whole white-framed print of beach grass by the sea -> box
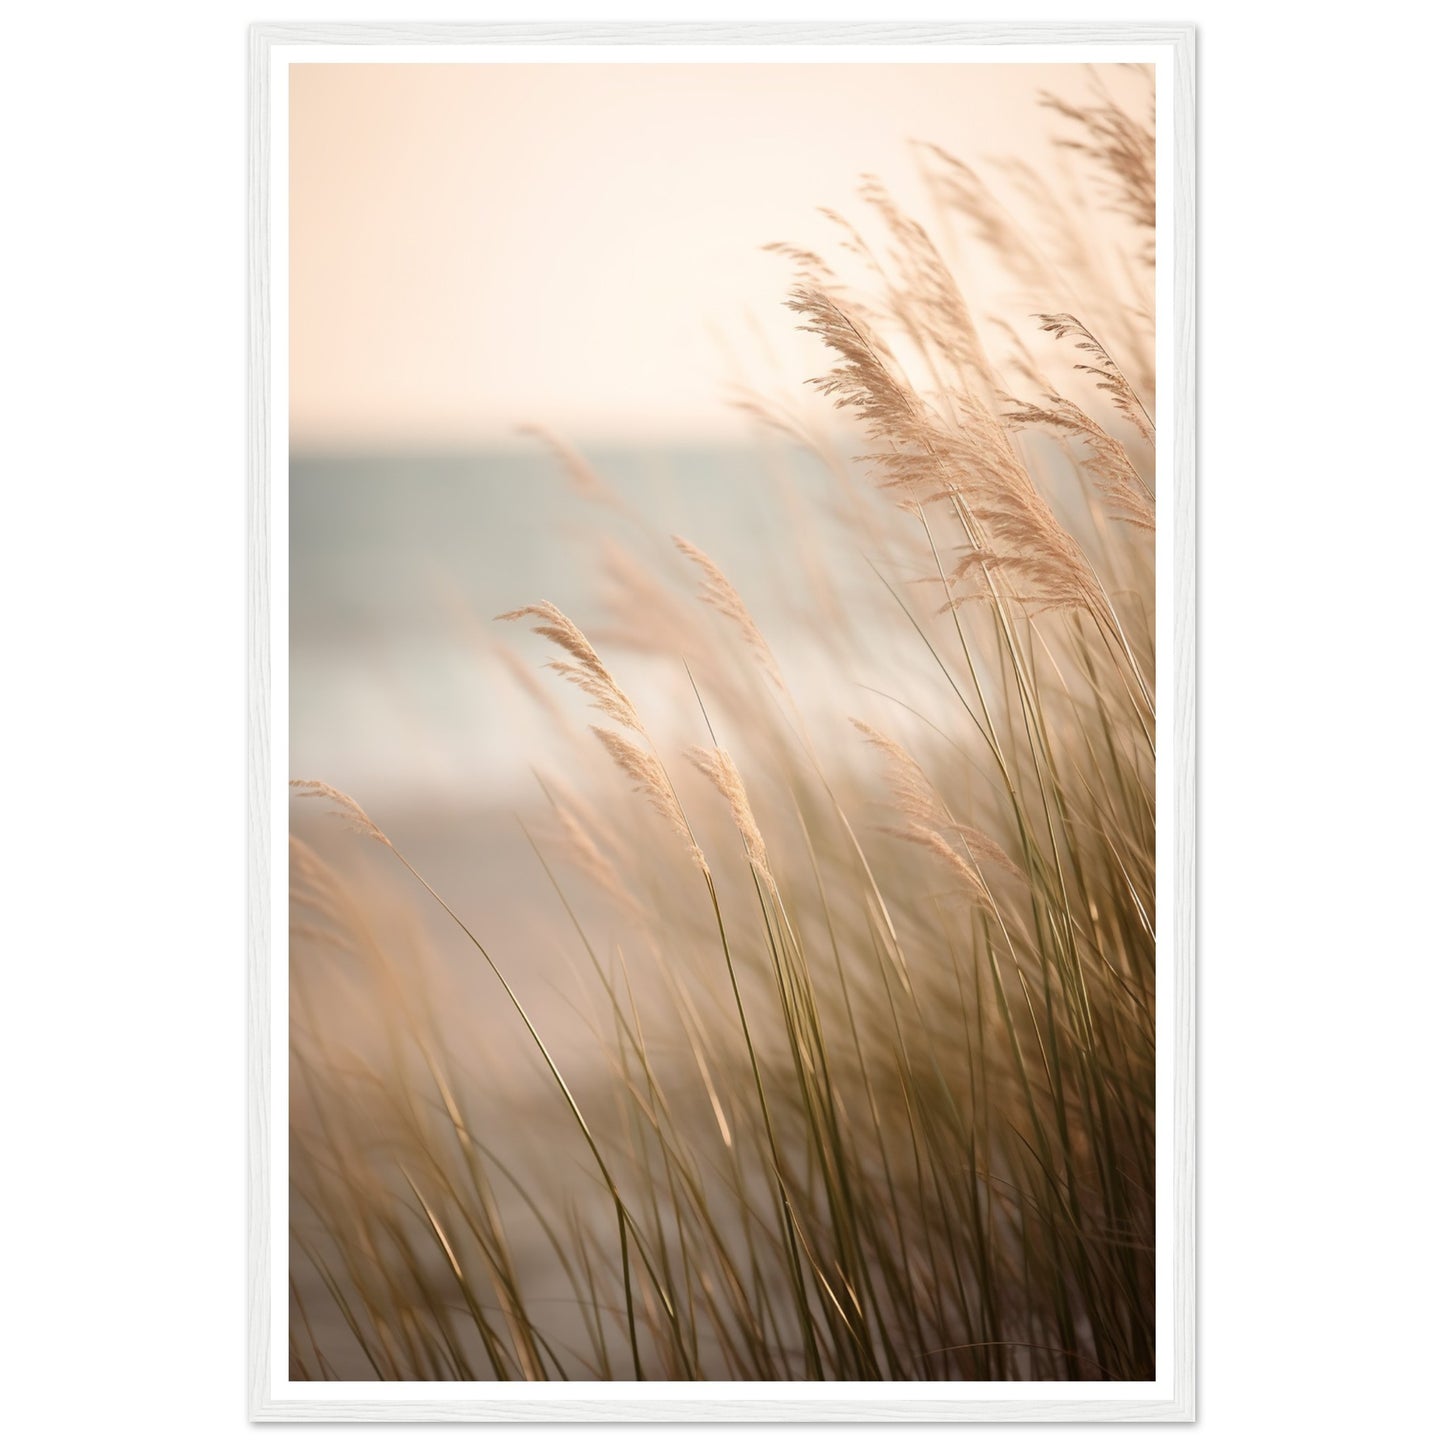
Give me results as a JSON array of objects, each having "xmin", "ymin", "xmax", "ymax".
[{"xmin": 250, "ymin": 25, "xmax": 1195, "ymax": 1422}]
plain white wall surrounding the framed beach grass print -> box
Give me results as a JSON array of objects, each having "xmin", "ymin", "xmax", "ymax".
[{"xmin": 0, "ymin": 0, "xmax": 1442, "ymax": 1442}]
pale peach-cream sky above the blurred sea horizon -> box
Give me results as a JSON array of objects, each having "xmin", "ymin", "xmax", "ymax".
[{"xmin": 290, "ymin": 64, "xmax": 1138, "ymax": 449}]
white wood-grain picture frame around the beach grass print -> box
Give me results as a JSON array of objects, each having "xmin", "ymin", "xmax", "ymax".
[{"xmin": 247, "ymin": 22, "xmax": 1195, "ymax": 1423}]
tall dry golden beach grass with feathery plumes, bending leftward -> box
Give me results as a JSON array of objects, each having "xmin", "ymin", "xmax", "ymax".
[{"xmin": 292, "ymin": 82, "xmax": 1155, "ymax": 1380}]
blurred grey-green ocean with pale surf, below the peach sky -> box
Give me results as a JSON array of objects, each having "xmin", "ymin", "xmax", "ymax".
[{"xmin": 289, "ymin": 445, "xmax": 857, "ymax": 808}]
